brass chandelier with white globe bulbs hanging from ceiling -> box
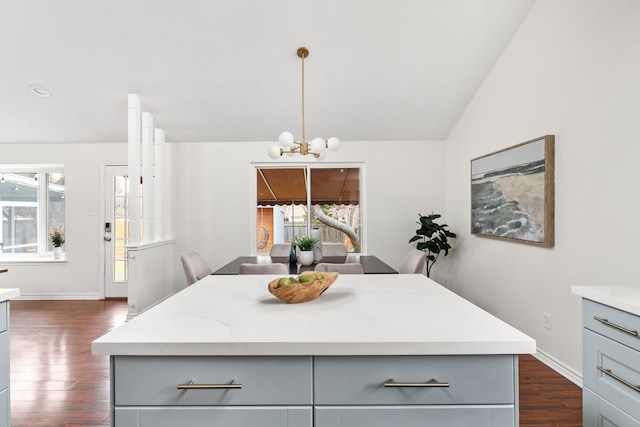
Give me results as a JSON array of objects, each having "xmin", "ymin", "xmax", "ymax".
[{"xmin": 269, "ymin": 47, "xmax": 340, "ymax": 160}]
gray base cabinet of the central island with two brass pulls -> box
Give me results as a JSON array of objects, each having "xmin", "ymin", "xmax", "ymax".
[{"xmin": 111, "ymin": 355, "xmax": 518, "ymax": 427}]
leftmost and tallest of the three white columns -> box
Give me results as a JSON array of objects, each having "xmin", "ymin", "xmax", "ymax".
[{"xmin": 127, "ymin": 94, "xmax": 141, "ymax": 246}]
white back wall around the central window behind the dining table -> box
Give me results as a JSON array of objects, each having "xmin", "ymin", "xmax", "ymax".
[{"xmin": 173, "ymin": 141, "xmax": 445, "ymax": 286}]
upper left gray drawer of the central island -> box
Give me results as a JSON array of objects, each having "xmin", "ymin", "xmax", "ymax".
[{"xmin": 117, "ymin": 356, "xmax": 313, "ymax": 406}]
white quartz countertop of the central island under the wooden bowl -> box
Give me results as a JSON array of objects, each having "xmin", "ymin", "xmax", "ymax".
[{"xmin": 92, "ymin": 274, "xmax": 536, "ymax": 356}]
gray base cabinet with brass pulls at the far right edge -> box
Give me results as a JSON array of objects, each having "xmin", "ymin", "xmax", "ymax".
[{"xmin": 583, "ymin": 299, "xmax": 640, "ymax": 427}]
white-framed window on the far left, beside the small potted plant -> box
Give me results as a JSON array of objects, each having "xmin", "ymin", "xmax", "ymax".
[{"xmin": 0, "ymin": 165, "xmax": 65, "ymax": 260}]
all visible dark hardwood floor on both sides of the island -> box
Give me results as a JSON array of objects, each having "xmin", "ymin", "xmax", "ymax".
[{"xmin": 11, "ymin": 300, "xmax": 582, "ymax": 427}]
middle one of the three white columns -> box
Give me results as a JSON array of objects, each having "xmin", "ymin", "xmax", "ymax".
[{"xmin": 142, "ymin": 113, "xmax": 156, "ymax": 243}]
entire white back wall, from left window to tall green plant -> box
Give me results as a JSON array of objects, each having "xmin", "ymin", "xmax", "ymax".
[{"xmin": 0, "ymin": 141, "xmax": 445, "ymax": 299}]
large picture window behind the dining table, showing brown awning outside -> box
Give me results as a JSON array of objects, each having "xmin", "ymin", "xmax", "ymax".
[{"xmin": 256, "ymin": 166, "xmax": 362, "ymax": 254}]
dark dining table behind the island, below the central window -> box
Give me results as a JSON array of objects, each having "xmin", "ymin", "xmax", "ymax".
[{"xmin": 211, "ymin": 254, "xmax": 398, "ymax": 275}]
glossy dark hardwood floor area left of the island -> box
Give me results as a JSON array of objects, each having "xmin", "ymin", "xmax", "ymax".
[{"xmin": 10, "ymin": 300, "xmax": 127, "ymax": 427}]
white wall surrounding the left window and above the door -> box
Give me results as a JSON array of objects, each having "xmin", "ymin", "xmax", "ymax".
[{"xmin": 0, "ymin": 143, "xmax": 127, "ymax": 299}]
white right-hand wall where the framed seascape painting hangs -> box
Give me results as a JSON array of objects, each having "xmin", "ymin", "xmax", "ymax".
[{"xmin": 446, "ymin": 0, "xmax": 640, "ymax": 380}]
